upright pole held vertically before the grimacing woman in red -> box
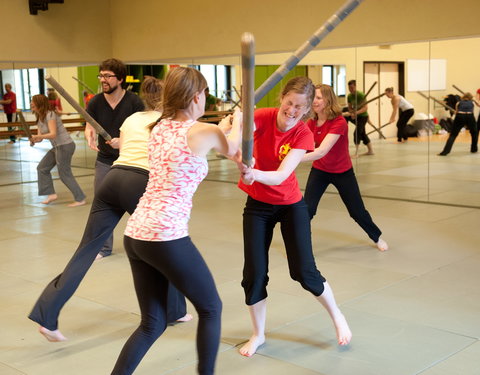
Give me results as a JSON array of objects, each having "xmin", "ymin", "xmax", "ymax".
[{"xmin": 241, "ymin": 33, "xmax": 255, "ymax": 167}]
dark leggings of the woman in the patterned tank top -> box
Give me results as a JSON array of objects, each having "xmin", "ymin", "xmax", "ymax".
[{"xmin": 112, "ymin": 236, "xmax": 222, "ymax": 375}]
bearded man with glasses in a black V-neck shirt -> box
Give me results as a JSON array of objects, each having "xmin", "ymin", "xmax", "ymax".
[{"xmin": 85, "ymin": 59, "xmax": 144, "ymax": 259}]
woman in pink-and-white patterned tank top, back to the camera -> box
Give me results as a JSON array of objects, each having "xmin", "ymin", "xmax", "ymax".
[{"xmin": 112, "ymin": 67, "xmax": 241, "ymax": 374}]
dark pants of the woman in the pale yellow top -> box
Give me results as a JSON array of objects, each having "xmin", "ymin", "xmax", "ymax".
[{"xmin": 28, "ymin": 167, "xmax": 186, "ymax": 331}]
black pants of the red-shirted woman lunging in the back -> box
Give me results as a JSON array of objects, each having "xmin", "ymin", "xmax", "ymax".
[{"xmin": 305, "ymin": 168, "xmax": 382, "ymax": 243}]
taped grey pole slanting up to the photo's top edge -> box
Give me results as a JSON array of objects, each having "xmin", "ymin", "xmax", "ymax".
[{"xmin": 255, "ymin": 0, "xmax": 363, "ymax": 104}]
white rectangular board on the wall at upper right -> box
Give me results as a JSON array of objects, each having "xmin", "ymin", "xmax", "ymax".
[{"xmin": 407, "ymin": 59, "xmax": 447, "ymax": 91}]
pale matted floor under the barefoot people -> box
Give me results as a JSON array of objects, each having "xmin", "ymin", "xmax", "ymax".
[{"xmin": 0, "ymin": 137, "xmax": 480, "ymax": 375}]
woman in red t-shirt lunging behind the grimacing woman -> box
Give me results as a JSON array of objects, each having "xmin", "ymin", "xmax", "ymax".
[{"xmin": 302, "ymin": 85, "xmax": 388, "ymax": 251}]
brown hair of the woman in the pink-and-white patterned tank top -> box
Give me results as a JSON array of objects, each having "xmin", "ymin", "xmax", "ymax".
[{"xmin": 149, "ymin": 66, "xmax": 207, "ymax": 130}]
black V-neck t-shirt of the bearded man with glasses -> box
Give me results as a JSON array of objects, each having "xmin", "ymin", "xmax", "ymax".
[{"xmin": 87, "ymin": 91, "xmax": 144, "ymax": 165}]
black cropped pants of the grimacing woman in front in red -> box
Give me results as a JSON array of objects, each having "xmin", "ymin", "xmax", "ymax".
[{"xmin": 242, "ymin": 197, "xmax": 325, "ymax": 305}]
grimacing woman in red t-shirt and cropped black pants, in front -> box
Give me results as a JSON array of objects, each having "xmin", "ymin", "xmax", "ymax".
[{"xmin": 239, "ymin": 77, "xmax": 352, "ymax": 357}]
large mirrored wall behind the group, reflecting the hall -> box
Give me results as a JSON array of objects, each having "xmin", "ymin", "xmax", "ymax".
[{"xmin": 0, "ymin": 38, "xmax": 480, "ymax": 207}]
